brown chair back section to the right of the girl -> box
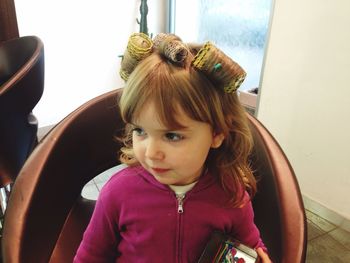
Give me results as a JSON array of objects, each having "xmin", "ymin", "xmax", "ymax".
[{"xmin": 248, "ymin": 115, "xmax": 307, "ymax": 263}]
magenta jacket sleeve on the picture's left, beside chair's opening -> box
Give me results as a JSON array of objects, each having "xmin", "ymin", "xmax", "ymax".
[{"xmin": 73, "ymin": 189, "xmax": 119, "ymax": 263}]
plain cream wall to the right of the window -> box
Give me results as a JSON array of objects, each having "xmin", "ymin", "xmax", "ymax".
[{"xmin": 258, "ymin": 0, "xmax": 350, "ymax": 219}]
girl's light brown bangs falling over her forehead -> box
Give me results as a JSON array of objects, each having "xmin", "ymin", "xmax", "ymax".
[{"xmin": 120, "ymin": 54, "xmax": 213, "ymax": 129}]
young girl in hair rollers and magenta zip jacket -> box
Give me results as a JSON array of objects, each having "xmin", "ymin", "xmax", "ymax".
[{"xmin": 74, "ymin": 33, "xmax": 270, "ymax": 263}]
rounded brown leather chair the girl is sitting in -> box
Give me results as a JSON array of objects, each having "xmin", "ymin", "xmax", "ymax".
[{"xmin": 2, "ymin": 90, "xmax": 306, "ymax": 263}]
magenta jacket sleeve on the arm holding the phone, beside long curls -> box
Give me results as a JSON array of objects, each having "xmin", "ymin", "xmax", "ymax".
[{"xmin": 234, "ymin": 201, "xmax": 267, "ymax": 252}]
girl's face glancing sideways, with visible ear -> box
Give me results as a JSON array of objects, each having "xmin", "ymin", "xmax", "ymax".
[{"xmin": 132, "ymin": 103, "xmax": 224, "ymax": 185}]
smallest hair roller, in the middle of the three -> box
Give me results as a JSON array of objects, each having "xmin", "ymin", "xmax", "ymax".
[{"xmin": 153, "ymin": 33, "xmax": 188, "ymax": 63}]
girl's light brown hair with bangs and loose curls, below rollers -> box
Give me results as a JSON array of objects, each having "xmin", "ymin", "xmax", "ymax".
[{"xmin": 119, "ymin": 45, "xmax": 256, "ymax": 206}]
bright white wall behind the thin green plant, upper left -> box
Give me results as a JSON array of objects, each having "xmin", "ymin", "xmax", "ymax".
[{"xmin": 15, "ymin": 0, "xmax": 166, "ymax": 127}]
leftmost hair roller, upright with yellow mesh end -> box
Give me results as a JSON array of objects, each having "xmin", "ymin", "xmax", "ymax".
[{"xmin": 119, "ymin": 33, "xmax": 153, "ymax": 81}]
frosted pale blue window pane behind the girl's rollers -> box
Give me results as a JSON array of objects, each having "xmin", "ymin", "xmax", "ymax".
[{"xmin": 175, "ymin": 0, "xmax": 272, "ymax": 90}]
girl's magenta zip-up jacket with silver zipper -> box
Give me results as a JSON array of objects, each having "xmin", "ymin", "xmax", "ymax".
[{"xmin": 74, "ymin": 167, "xmax": 265, "ymax": 263}]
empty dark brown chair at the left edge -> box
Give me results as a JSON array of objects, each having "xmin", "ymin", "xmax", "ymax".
[{"xmin": 0, "ymin": 36, "xmax": 44, "ymax": 187}]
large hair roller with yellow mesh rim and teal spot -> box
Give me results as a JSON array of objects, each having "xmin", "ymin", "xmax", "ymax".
[{"xmin": 192, "ymin": 42, "xmax": 247, "ymax": 93}]
